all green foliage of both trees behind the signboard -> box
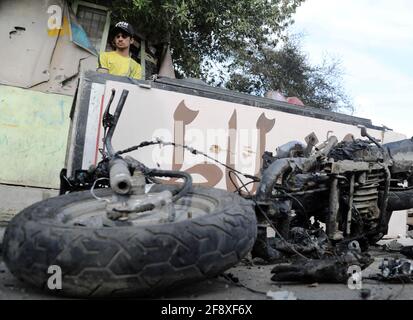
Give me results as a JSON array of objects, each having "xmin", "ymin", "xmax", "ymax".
[{"xmin": 108, "ymin": 0, "xmax": 351, "ymax": 110}]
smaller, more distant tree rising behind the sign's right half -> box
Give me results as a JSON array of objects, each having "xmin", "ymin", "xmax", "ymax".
[{"xmin": 225, "ymin": 38, "xmax": 353, "ymax": 111}]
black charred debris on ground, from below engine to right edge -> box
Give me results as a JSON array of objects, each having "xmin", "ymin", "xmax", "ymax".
[{"xmin": 248, "ymin": 221, "xmax": 413, "ymax": 286}]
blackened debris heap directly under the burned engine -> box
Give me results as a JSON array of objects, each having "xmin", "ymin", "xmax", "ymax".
[{"xmin": 252, "ymin": 227, "xmax": 374, "ymax": 284}]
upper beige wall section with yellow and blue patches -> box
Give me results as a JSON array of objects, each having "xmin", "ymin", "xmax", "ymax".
[{"xmin": 0, "ymin": 0, "xmax": 97, "ymax": 96}]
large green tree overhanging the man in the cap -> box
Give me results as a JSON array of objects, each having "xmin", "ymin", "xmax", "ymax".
[{"xmin": 108, "ymin": 0, "xmax": 304, "ymax": 79}]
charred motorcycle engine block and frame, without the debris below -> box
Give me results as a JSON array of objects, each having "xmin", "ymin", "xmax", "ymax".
[{"xmin": 253, "ymin": 126, "xmax": 413, "ymax": 262}]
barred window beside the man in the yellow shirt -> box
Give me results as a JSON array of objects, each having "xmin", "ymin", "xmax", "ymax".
[{"xmin": 73, "ymin": 1, "xmax": 110, "ymax": 52}]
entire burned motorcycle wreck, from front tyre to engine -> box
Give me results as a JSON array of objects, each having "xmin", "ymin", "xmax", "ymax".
[{"xmin": 2, "ymin": 90, "xmax": 413, "ymax": 297}]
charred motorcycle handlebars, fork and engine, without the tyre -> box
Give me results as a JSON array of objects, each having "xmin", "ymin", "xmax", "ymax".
[{"xmin": 61, "ymin": 91, "xmax": 413, "ymax": 255}]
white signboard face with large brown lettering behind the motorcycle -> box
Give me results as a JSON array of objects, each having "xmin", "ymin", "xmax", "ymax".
[{"xmin": 81, "ymin": 81, "xmax": 405, "ymax": 191}]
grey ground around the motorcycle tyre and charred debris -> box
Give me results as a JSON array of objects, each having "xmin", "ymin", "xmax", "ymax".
[{"xmin": 0, "ymin": 239, "xmax": 413, "ymax": 300}]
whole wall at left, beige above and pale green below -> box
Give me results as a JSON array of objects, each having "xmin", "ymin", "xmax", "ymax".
[{"xmin": 0, "ymin": 0, "xmax": 97, "ymax": 190}]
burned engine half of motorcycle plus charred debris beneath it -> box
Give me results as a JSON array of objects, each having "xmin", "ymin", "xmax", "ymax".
[{"xmin": 252, "ymin": 128, "xmax": 413, "ymax": 282}]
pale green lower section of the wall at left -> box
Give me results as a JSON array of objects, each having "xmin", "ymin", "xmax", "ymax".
[{"xmin": 0, "ymin": 85, "xmax": 73, "ymax": 188}]
